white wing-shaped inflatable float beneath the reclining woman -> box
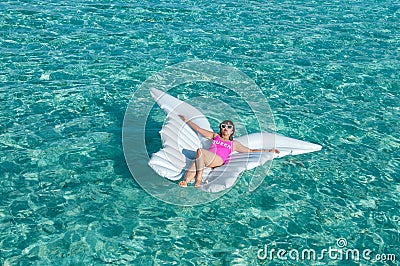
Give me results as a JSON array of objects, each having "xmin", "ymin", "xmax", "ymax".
[{"xmin": 149, "ymin": 89, "xmax": 322, "ymax": 192}]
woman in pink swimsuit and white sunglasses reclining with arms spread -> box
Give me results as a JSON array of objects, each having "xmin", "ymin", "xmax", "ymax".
[{"xmin": 179, "ymin": 115, "xmax": 279, "ymax": 187}]
